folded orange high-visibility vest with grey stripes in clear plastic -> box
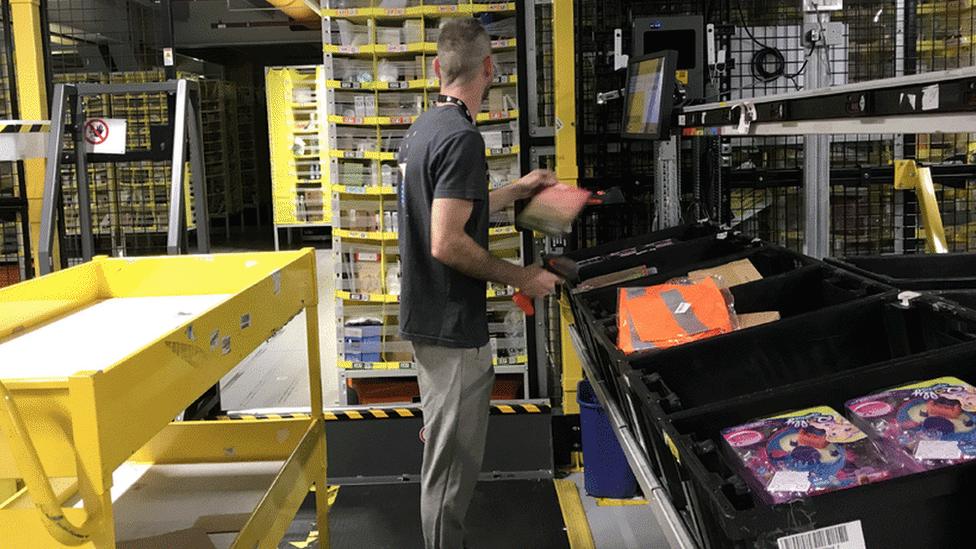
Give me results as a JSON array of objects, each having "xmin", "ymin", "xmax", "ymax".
[{"xmin": 617, "ymin": 278, "xmax": 733, "ymax": 353}]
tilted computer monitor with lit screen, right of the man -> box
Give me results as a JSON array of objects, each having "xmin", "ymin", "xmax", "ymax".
[{"xmin": 622, "ymin": 50, "xmax": 678, "ymax": 139}]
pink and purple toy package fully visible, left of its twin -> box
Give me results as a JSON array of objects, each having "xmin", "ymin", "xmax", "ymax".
[{"xmin": 722, "ymin": 406, "xmax": 900, "ymax": 504}]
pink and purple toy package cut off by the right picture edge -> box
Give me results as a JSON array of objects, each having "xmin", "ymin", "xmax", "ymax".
[{"xmin": 847, "ymin": 377, "xmax": 976, "ymax": 471}]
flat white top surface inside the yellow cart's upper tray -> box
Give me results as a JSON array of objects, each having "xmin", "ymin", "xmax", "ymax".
[{"xmin": 0, "ymin": 294, "xmax": 231, "ymax": 379}]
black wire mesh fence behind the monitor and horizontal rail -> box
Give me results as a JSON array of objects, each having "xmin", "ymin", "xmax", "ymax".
[{"xmin": 576, "ymin": 0, "xmax": 976, "ymax": 255}]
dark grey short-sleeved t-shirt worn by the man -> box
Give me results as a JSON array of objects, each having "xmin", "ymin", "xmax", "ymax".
[{"xmin": 398, "ymin": 105, "xmax": 490, "ymax": 348}]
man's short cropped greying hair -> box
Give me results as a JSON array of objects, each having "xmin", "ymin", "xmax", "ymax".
[{"xmin": 437, "ymin": 17, "xmax": 491, "ymax": 86}]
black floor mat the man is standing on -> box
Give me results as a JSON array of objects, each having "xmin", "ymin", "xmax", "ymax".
[{"xmin": 281, "ymin": 480, "xmax": 569, "ymax": 549}]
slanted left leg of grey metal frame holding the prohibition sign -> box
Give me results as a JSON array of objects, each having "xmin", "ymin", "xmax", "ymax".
[{"xmin": 37, "ymin": 84, "xmax": 68, "ymax": 275}]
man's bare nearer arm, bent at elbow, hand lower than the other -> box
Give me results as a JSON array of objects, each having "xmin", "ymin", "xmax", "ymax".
[{"xmin": 430, "ymin": 198, "xmax": 559, "ymax": 297}]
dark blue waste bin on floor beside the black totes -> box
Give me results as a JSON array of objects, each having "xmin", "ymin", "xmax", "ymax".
[{"xmin": 576, "ymin": 380, "xmax": 637, "ymax": 499}]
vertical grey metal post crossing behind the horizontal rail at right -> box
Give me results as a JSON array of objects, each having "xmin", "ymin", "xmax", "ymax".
[{"xmin": 803, "ymin": 8, "xmax": 830, "ymax": 258}]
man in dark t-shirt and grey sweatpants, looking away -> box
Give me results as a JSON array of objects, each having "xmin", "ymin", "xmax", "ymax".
[{"xmin": 398, "ymin": 18, "xmax": 558, "ymax": 549}]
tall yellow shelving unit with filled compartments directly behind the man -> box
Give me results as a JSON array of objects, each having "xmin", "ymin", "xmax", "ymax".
[{"xmin": 322, "ymin": 0, "xmax": 528, "ymax": 398}]
